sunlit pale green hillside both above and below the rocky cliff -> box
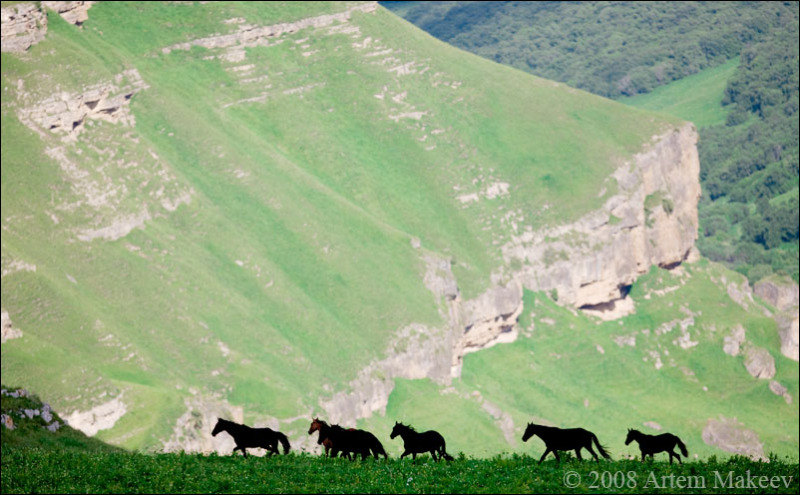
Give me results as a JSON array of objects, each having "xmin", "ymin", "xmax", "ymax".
[{"xmin": 1, "ymin": 2, "xmax": 800, "ymax": 464}]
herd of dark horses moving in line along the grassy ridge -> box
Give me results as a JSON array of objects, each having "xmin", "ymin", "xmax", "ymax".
[{"xmin": 211, "ymin": 418, "xmax": 689, "ymax": 464}]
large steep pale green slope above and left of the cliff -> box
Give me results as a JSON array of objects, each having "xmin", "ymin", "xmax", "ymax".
[{"xmin": 2, "ymin": 3, "xmax": 677, "ymax": 454}]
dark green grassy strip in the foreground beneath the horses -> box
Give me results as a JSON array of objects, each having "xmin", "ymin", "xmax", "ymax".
[{"xmin": 2, "ymin": 446, "xmax": 798, "ymax": 493}]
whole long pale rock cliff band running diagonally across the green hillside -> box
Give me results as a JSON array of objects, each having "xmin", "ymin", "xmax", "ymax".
[{"xmin": 320, "ymin": 124, "xmax": 700, "ymax": 423}]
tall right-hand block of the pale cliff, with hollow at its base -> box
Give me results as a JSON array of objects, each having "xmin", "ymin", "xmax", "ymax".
[{"xmin": 503, "ymin": 124, "xmax": 700, "ymax": 309}]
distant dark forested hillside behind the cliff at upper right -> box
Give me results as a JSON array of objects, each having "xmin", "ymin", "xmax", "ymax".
[{"xmin": 382, "ymin": 1, "xmax": 800, "ymax": 284}]
